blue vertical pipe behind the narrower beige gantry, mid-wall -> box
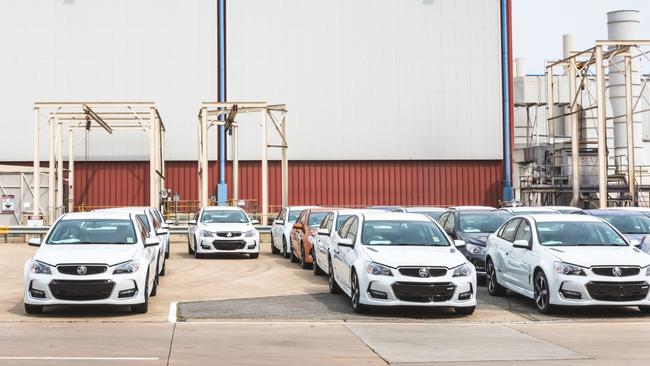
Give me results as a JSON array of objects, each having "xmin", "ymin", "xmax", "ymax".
[{"xmin": 217, "ymin": 0, "xmax": 228, "ymax": 204}]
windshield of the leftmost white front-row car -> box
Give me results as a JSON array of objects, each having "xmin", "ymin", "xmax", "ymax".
[{"xmin": 47, "ymin": 219, "xmax": 137, "ymax": 244}]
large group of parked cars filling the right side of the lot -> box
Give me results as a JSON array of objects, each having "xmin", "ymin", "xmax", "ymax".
[{"xmin": 272, "ymin": 206, "xmax": 650, "ymax": 314}]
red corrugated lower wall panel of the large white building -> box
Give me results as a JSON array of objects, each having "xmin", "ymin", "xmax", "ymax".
[{"xmin": 68, "ymin": 160, "xmax": 503, "ymax": 212}]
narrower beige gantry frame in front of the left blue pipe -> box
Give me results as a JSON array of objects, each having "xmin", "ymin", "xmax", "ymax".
[{"xmin": 198, "ymin": 102, "xmax": 289, "ymax": 225}]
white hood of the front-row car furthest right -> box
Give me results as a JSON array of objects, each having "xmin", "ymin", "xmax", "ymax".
[{"xmin": 545, "ymin": 246, "xmax": 650, "ymax": 267}]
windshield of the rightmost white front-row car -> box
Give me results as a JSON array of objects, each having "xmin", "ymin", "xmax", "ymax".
[{"xmin": 537, "ymin": 221, "xmax": 627, "ymax": 246}]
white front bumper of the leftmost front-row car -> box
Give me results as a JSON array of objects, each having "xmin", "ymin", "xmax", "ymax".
[{"xmin": 24, "ymin": 273, "xmax": 145, "ymax": 305}]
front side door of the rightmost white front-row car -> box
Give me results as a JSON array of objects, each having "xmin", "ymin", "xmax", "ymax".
[{"xmin": 507, "ymin": 219, "xmax": 536, "ymax": 291}]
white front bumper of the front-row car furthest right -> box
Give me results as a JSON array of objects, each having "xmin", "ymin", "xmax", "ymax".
[{"xmin": 549, "ymin": 275, "xmax": 650, "ymax": 306}]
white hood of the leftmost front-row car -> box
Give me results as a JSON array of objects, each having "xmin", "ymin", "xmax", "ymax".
[{"xmin": 34, "ymin": 244, "xmax": 142, "ymax": 266}]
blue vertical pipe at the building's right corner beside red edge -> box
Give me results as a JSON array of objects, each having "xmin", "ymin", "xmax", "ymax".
[{"xmin": 501, "ymin": 0, "xmax": 512, "ymax": 201}]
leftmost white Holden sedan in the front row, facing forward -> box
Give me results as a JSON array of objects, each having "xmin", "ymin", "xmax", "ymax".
[{"xmin": 24, "ymin": 212, "xmax": 160, "ymax": 314}]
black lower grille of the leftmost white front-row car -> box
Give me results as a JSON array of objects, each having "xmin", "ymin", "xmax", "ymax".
[{"xmin": 50, "ymin": 280, "xmax": 115, "ymax": 301}]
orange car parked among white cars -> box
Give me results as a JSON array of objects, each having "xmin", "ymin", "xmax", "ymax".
[{"xmin": 289, "ymin": 208, "xmax": 332, "ymax": 269}]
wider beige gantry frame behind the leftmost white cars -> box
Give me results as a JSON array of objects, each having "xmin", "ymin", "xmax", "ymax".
[{"xmin": 34, "ymin": 102, "xmax": 165, "ymax": 224}]
